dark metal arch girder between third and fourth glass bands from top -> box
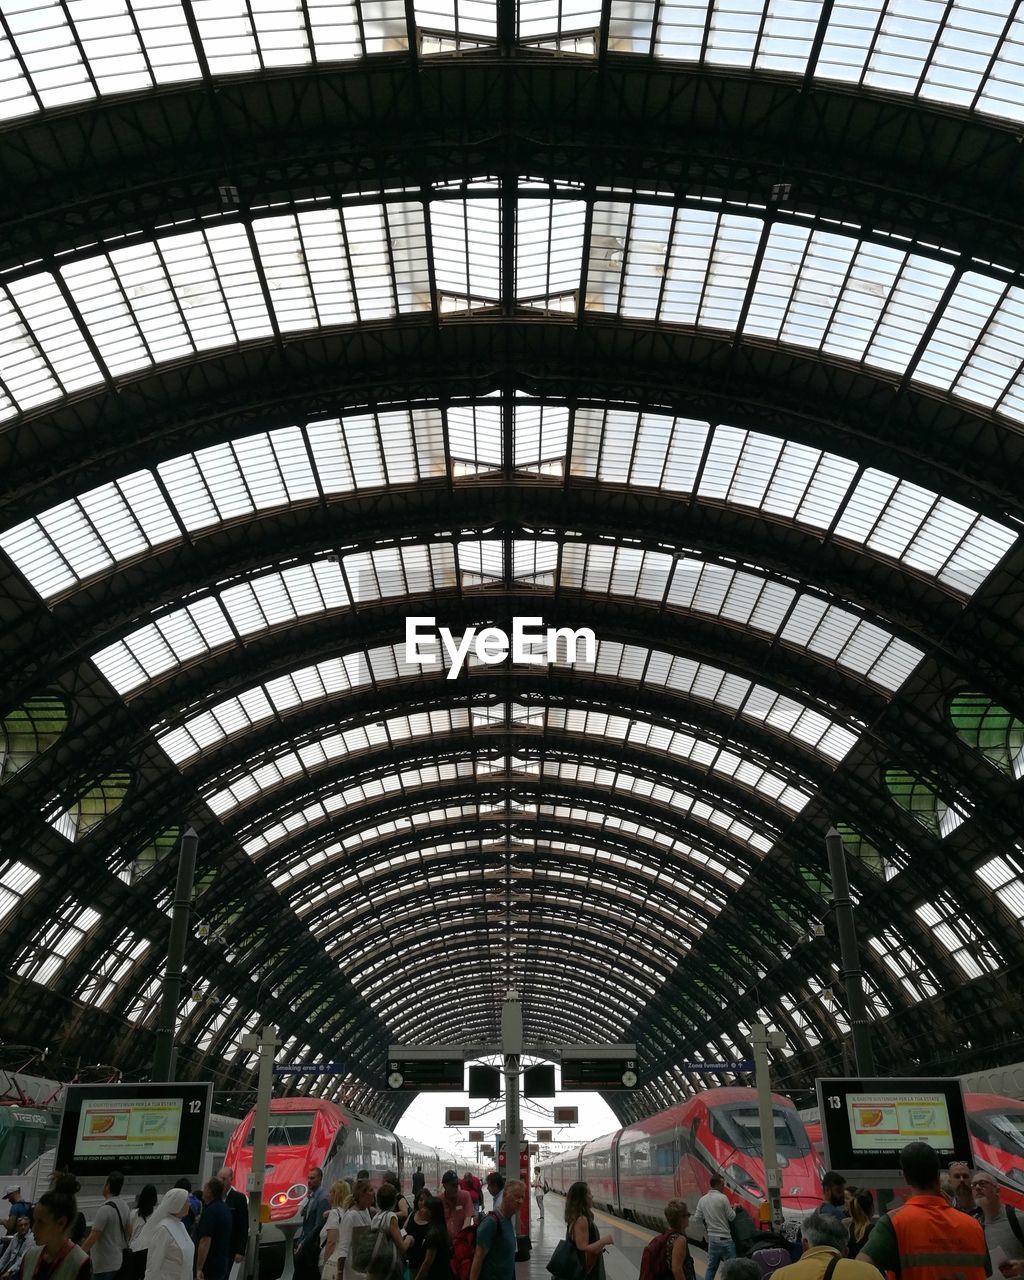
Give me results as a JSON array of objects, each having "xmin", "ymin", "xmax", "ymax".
[{"xmin": 8, "ymin": 494, "xmax": 1024, "ymax": 691}]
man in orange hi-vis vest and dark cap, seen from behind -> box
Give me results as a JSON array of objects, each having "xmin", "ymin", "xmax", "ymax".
[{"xmin": 858, "ymin": 1142, "xmax": 992, "ymax": 1280}]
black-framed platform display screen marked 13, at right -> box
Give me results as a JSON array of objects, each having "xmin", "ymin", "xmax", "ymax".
[{"xmin": 817, "ymin": 1079, "xmax": 970, "ymax": 1180}]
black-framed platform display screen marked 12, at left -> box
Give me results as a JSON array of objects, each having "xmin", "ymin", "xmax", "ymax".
[{"xmin": 56, "ymin": 1084, "xmax": 212, "ymax": 1178}]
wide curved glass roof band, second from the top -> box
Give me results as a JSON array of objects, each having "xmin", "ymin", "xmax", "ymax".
[{"xmin": 0, "ymin": 192, "xmax": 1024, "ymax": 437}]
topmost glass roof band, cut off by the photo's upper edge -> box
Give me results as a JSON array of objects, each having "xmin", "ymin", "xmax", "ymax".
[{"xmin": 0, "ymin": 0, "xmax": 1024, "ymax": 120}]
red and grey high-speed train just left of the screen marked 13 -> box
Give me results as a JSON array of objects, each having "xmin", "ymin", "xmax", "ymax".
[{"xmin": 538, "ymin": 1088, "xmax": 823, "ymax": 1230}]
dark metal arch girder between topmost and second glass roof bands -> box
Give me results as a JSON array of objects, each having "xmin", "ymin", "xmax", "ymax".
[{"xmin": 0, "ymin": 60, "xmax": 1021, "ymax": 275}]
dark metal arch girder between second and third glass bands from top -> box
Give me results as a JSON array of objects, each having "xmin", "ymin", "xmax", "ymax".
[{"xmin": 0, "ymin": 325, "xmax": 1024, "ymax": 520}]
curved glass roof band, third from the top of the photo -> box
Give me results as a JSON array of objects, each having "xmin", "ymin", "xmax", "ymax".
[{"xmin": 0, "ymin": 401, "xmax": 1016, "ymax": 599}]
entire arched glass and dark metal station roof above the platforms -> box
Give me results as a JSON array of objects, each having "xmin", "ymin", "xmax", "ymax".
[{"xmin": 0, "ymin": 0, "xmax": 1024, "ymax": 1125}]
